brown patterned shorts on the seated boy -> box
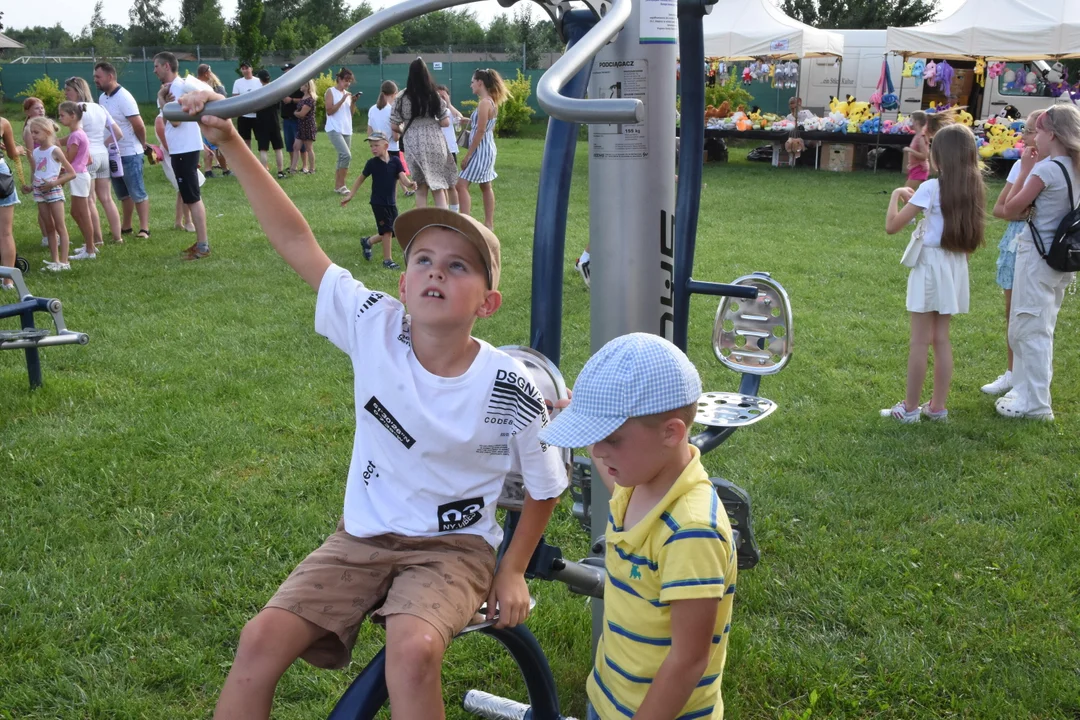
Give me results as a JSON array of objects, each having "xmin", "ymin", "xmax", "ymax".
[{"xmin": 266, "ymin": 524, "xmax": 495, "ymax": 668}]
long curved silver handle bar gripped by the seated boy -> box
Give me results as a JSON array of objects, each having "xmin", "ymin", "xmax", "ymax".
[{"xmin": 163, "ymin": 0, "xmax": 483, "ymax": 122}]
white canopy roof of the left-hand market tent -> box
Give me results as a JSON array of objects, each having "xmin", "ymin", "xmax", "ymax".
[{"xmin": 703, "ymin": 0, "xmax": 842, "ymax": 60}]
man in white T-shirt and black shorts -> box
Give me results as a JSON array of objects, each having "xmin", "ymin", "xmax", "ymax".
[{"xmin": 153, "ymin": 53, "xmax": 213, "ymax": 260}]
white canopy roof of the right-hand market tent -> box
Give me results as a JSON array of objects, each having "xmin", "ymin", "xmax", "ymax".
[{"xmin": 886, "ymin": 0, "xmax": 1080, "ymax": 62}]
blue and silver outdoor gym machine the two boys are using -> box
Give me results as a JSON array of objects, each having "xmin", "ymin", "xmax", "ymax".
[{"xmin": 164, "ymin": 0, "xmax": 792, "ymax": 720}]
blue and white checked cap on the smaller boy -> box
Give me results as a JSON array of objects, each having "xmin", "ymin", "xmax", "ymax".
[{"xmin": 540, "ymin": 332, "xmax": 701, "ymax": 448}]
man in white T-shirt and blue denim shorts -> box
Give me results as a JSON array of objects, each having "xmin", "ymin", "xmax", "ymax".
[{"xmin": 94, "ymin": 62, "xmax": 150, "ymax": 237}]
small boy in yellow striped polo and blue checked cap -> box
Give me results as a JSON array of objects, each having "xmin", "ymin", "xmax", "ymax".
[{"xmin": 540, "ymin": 332, "xmax": 735, "ymax": 720}]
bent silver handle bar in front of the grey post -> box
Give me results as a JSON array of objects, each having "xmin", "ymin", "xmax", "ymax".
[{"xmin": 537, "ymin": 0, "xmax": 645, "ymax": 124}]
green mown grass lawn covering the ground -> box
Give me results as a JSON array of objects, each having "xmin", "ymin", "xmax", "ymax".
[{"xmin": 0, "ymin": 120, "xmax": 1080, "ymax": 720}]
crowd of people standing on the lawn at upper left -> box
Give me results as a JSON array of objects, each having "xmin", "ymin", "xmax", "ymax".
[{"xmin": 0, "ymin": 52, "xmax": 508, "ymax": 278}]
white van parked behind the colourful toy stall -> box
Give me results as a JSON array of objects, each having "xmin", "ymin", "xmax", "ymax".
[{"xmin": 798, "ymin": 30, "xmax": 1070, "ymax": 119}]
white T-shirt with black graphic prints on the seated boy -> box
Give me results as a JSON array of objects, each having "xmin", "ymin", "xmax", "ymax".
[{"xmin": 315, "ymin": 266, "xmax": 567, "ymax": 547}]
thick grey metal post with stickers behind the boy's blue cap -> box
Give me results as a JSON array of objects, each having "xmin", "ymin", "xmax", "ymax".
[{"xmin": 589, "ymin": 0, "xmax": 678, "ymax": 646}]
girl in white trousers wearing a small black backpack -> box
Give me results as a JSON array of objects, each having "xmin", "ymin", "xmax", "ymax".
[{"xmin": 995, "ymin": 105, "xmax": 1080, "ymax": 420}]
